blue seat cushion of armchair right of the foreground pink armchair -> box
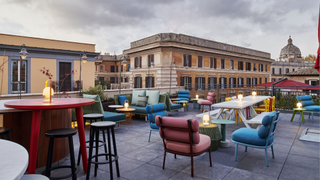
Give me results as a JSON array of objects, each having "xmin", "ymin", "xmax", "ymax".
[{"xmin": 232, "ymin": 128, "xmax": 274, "ymax": 146}]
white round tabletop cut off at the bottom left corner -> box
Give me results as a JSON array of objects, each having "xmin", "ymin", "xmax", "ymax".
[{"xmin": 0, "ymin": 139, "xmax": 28, "ymax": 179}]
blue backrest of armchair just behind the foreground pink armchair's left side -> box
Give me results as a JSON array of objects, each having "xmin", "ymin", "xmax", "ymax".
[{"xmin": 146, "ymin": 103, "xmax": 168, "ymax": 126}]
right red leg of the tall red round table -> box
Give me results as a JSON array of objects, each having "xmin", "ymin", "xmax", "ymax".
[{"xmin": 75, "ymin": 107, "xmax": 88, "ymax": 172}]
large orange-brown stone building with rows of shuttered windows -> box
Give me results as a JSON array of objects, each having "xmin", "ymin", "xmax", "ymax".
[{"xmin": 123, "ymin": 33, "xmax": 274, "ymax": 97}]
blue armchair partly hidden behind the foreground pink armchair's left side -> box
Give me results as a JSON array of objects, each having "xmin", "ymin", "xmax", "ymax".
[{"xmin": 146, "ymin": 103, "xmax": 168, "ymax": 142}]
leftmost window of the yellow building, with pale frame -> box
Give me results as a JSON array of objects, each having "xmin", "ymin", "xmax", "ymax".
[{"xmin": 11, "ymin": 60, "xmax": 27, "ymax": 93}]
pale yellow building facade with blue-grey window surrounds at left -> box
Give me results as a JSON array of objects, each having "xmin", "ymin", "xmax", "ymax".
[{"xmin": 0, "ymin": 34, "xmax": 98, "ymax": 94}]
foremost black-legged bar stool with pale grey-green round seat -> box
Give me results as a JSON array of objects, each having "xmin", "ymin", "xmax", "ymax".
[{"xmin": 86, "ymin": 121, "xmax": 120, "ymax": 180}]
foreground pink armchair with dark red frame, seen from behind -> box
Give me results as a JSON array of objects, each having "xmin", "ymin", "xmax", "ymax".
[{"xmin": 155, "ymin": 116, "xmax": 212, "ymax": 177}]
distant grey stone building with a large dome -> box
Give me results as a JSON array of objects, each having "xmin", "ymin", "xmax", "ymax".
[{"xmin": 271, "ymin": 36, "xmax": 314, "ymax": 81}]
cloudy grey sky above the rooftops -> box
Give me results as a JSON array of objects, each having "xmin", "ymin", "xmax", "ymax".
[{"xmin": 0, "ymin": 0, "xmax": 319, "ymax": 60}]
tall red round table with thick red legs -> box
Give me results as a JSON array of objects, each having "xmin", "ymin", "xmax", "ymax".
[{"xmin": 4, "ymin": 98, "xmax": 94, "ymax": 174}]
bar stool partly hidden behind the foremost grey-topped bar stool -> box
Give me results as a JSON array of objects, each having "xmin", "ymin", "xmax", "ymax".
[{"xmin": 77, "ymin": 113, "xmax": 108, "ymax": 166}]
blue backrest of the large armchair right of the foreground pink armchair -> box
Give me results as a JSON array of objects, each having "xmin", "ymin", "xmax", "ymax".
[{"xmin": 258, "ymin": 111, "xmax": 279, "ymax": 146}]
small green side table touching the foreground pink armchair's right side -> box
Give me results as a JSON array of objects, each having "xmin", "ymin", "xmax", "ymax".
[{"xmin": 199, "ymin": 123, "xmax": 222, "ymax": 151}]
